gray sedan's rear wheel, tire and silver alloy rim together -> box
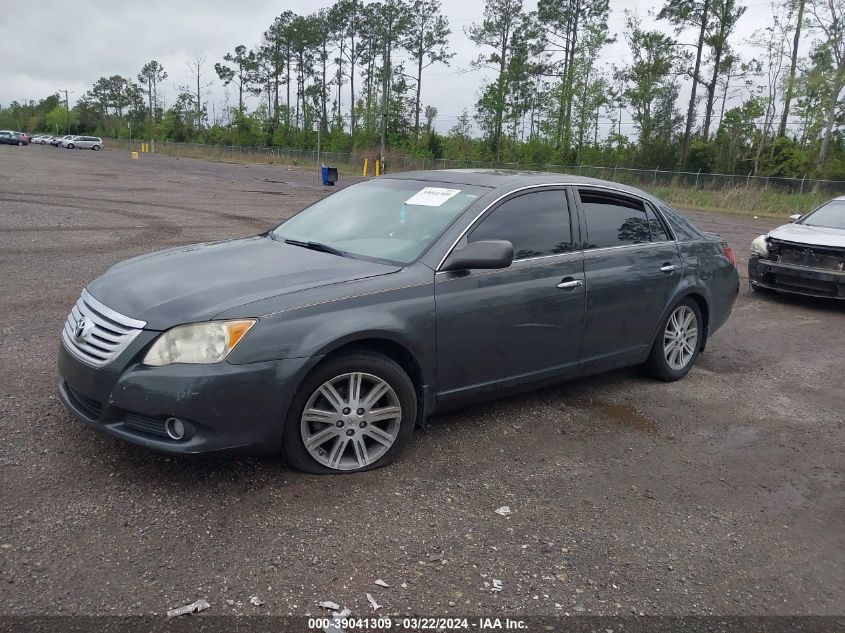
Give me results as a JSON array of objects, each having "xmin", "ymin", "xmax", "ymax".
[{"xmin": 646, "ymin": 299, "xmax": 703, "ymax": 382}]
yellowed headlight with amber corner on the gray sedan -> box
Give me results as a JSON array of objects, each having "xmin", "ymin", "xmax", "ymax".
[{"xmin": 143, "ymin": 319, "xmax": 256, "ymax": 367}]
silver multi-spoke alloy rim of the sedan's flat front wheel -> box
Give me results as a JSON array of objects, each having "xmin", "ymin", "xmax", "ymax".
[{"xmin": 300, "ymin": 372, "xmax": 402, "ymax": 470}]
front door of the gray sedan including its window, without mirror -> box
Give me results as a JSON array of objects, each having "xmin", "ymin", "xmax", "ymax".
[{"xmin": 434, "ymin": 188, "xmax": 585, "ymax": 400}]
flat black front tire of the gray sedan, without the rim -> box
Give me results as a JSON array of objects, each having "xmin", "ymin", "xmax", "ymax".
[{"xmin": 282, "ymin": 350, "xmax": 417, "ymax": 475}]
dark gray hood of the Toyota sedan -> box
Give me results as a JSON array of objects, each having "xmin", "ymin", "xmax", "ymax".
[{"xmin": 88, "ymin": 235, "xmax": 400, "ymax": 330}]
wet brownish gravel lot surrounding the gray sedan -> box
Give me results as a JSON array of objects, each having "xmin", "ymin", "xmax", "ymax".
[{"xmin": 0, "ymin": 146, "xmax": 845, "ymax": 615}]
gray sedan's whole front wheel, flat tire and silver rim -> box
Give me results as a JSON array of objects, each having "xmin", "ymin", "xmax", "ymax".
[{"xmin": 283, "ymin": 351, "xmax": 417, "ymax": 474}]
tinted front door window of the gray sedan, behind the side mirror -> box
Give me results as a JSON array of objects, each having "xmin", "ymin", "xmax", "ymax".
[{"xmin": 467, "ymin": 190, "xmax": 572, "ymax": 259}]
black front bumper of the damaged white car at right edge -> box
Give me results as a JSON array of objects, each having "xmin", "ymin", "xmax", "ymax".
[{"xmin": 748, "ymin": 255, "xmax": 845, "ymax": 299}]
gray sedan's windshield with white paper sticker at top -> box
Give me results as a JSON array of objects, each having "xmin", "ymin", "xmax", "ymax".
[{"xmin": 273, "ymin": 179, "xmax": 489, "ymax": 264}]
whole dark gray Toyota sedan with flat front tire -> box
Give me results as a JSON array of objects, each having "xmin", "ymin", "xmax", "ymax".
[{"xmin": 59, "ymin": 170, "xmax": 739, "ymax": 473}]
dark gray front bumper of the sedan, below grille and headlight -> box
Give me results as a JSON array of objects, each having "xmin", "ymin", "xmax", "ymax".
[{"xmin": 59, "ymin": 345, "xmax": 316, "ymax": 455}]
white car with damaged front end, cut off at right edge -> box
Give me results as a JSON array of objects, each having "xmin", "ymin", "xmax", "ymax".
[{"xmin": 748, "ymin": 196, "xmax": 845, "ymax": 299}]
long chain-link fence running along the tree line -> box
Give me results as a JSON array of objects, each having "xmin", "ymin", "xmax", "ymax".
[{"xmin": 104, "ymin": 139, "xmax": 845, "ymax": 194}]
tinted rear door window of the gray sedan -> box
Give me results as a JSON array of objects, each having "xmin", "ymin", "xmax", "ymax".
[{"xmin": 578, "ymin": 190, "xmax": 651, "ymax": 248}]
